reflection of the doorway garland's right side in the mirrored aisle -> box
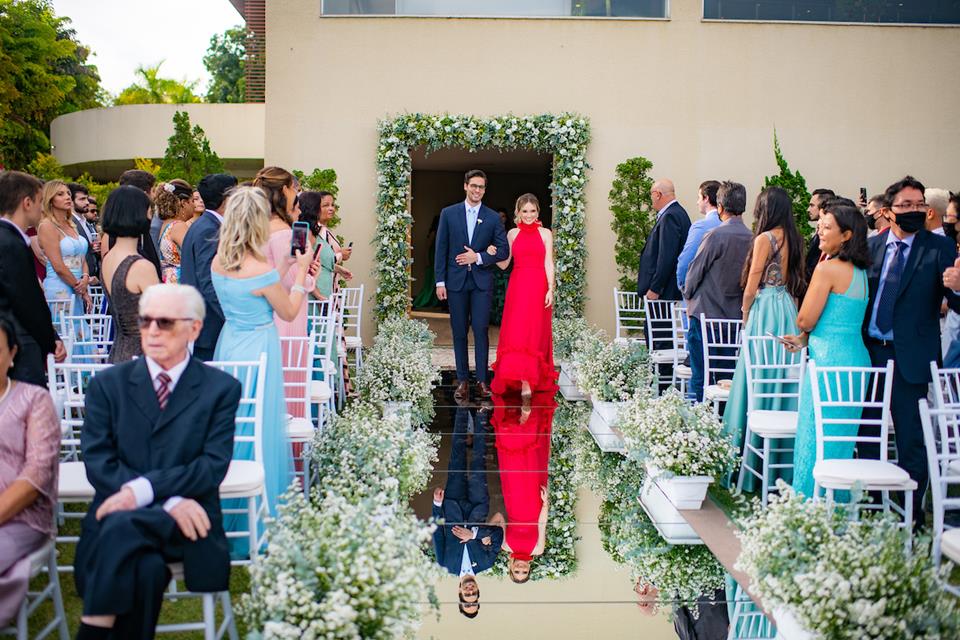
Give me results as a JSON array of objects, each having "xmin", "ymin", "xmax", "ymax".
[{"xmin": 491, "ymin": 399, "xmax": 580, "ymax": 581}]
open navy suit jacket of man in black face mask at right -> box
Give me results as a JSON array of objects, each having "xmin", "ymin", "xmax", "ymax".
[{"xmin": 863, "ymin": 230, "xmax": 960, "ymax": 384}]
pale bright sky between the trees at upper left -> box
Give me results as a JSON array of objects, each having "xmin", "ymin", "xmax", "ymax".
[{"xmin": 53, "ymin": 0, "xmax": 243, "ymax": 95}]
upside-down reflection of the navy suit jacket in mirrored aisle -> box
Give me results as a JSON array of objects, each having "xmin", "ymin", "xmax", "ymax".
[{"xmin": 433, "ymin": 502, "xmax": 503, "ymax": 576}]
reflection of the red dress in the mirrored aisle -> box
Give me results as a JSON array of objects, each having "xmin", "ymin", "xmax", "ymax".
[{"xmin": 491, "ymin": 394, "xmax": 556, "ymax": 560}]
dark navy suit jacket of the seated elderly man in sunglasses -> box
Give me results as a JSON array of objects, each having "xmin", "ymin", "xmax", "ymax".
[{"xmin": 75, "ymin": 358, "xmax": 241, "ymax": 592}]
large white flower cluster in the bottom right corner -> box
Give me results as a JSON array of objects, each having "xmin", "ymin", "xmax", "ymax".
[{"xmin": 737, "ymin": 480, "xmax": 960, "ymax": 640}]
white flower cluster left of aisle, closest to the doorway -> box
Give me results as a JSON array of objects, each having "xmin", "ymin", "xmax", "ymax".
[{"xmin": 357, "ymin": 317, "xmax": 440, "ymax": 424}]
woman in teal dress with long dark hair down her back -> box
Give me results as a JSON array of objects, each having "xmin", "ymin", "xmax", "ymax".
[{"xmin": 723, "ymin": 187, "xmax": 806, "ymax": 491}]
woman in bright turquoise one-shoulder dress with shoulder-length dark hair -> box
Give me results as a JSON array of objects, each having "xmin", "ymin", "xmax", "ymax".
[{"xmin": 785, "ymin": 200, "xmax": 870, "ymax": 501}]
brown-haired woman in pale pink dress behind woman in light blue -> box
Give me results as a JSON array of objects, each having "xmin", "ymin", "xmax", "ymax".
[{"xmin": 253, "ymin": 167, "xmax": 317, "ymax": 418}]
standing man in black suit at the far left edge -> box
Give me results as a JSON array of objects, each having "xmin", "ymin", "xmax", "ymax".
[{"xmin": 0, "ymin": 171, "xmax": 67, "ymax": 387}]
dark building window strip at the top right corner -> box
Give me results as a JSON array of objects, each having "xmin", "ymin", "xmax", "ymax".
[{"xmin": 703, "ymin": 0, "xmax": 960, "ymax": 24}]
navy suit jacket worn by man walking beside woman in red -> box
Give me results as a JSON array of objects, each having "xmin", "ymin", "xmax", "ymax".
[{"xmin": 433, "ymin": 202, "xmax": 510, "ymax": 291}]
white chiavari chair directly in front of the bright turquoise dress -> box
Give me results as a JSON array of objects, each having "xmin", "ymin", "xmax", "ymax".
[{"xmin": 808, "ymin": 360, "xmax": 917, "ymax": 531}]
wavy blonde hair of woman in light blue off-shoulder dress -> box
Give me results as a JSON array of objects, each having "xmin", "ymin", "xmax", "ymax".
[{"xmin": 217, "ymin": 187, "xmax": 270, "ymax": 271}]
